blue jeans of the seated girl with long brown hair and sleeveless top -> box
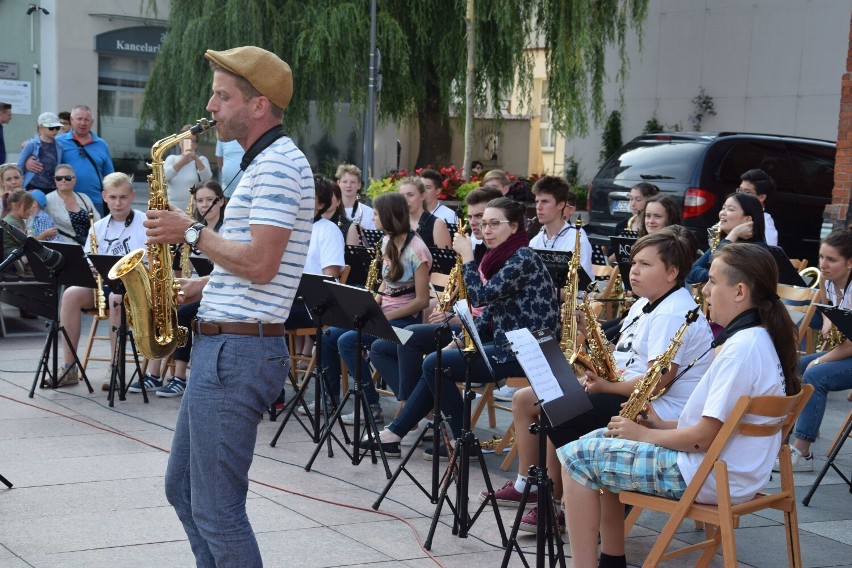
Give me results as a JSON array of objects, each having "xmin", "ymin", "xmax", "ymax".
[{"xmin": 322, "ymin": 315, "xmax": 420, "ymax": 405}]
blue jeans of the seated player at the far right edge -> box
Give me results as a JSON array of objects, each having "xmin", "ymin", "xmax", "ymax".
[{"xmin": 794, "ymin": 351, "xmax": 852, "ymax": 442}]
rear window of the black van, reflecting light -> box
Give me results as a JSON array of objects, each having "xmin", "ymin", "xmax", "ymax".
[{"xmin": 598, "ymin": 140, "xmax": 707, "ymax": 184}]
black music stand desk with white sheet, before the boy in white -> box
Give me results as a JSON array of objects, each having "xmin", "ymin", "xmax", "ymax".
[{"xmin": 506, "ymin": 328, "xmax": 592, "ymax": 430}]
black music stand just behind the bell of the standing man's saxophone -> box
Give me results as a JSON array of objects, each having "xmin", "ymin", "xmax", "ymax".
[{"xmin": 89, "ymin": 254, "xmax": 143, "ymax": 406}]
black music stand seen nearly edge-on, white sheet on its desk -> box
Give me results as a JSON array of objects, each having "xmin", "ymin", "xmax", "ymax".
[{"xmin": 423, "ymin": 302, "xmax": 507, "ymax": 550}]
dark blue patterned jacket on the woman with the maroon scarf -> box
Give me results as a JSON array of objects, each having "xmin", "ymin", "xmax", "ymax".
[{"xmin": 463, "ymin": 247, "xmax": 559, "ymax": 363}]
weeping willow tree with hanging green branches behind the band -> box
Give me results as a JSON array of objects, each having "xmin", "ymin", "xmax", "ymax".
[{"xmin": 142, "ymin": 0, "xmax": 648, "ymax": 169}]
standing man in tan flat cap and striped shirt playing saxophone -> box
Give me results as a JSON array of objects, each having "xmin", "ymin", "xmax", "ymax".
[{"xmin": 145, "ymin": 46, "xmax": 314, "ymax": 568}]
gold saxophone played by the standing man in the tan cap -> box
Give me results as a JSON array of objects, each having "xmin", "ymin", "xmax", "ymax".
[{"xmin": 109, "ymin": 118, "xmax": 216, "ymax": 359}]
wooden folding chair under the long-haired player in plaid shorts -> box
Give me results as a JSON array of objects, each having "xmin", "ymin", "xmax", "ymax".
[{"xmin": 619, "ymin": 385, "xmax": 813, "ymax": 568}]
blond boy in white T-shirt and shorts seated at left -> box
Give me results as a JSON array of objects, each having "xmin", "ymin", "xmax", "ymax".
[{"xmin": 57, "ymin": 172, "xmax": 145, "ymax": 390}]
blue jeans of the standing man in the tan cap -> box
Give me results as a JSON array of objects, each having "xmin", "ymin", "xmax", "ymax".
[{"xmin": 165, "ymin": 335, "xmax": 289, "ymax": 568}]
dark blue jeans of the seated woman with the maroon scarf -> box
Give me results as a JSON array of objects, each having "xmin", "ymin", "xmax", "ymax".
[{"xmin": 388, "ymin": 343, "xmax": 524, "ymax": 437}]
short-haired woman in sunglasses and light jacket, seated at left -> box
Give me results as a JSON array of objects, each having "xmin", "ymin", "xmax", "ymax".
[{"xmin": 44, "ymin": 164, "xmax": 101, "ymax": 245}]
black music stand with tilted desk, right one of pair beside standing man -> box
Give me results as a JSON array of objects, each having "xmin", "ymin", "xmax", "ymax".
[{"xmin": 305, "ymin": 282, "xmax": 402, "ymax": 479}]
